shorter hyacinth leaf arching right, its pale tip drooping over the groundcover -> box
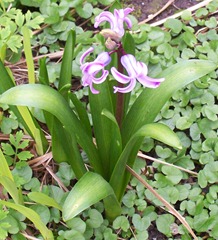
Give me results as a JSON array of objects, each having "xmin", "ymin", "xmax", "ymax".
[{"xmin": 110, "ymin": 123, "xmax": 181, "ymax": 201}]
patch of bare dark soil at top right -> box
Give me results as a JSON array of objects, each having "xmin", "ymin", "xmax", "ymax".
[{"xmin": 123, "ymin": 0, "xmax": 202, "ymax": 22}]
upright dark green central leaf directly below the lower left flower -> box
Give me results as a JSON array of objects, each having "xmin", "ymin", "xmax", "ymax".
[{"xmin": 89, "ymin": 81, "xmax": 121, "ymax": 180}]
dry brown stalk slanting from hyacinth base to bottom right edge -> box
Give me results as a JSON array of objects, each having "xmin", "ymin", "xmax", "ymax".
[{"xmin": 126, "ymin": 165, "xmax": 198, "ymax": 240}]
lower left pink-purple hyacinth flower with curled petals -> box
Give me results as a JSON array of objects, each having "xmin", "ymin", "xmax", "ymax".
[{"xmin": 80, "ymin": 47, "xmax": 111, "ymax": 94}]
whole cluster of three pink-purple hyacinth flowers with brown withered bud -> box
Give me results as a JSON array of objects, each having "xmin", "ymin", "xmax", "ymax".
[{"xmin": 80, "ymin": 8, "xmax": 164, "ymax": 94}]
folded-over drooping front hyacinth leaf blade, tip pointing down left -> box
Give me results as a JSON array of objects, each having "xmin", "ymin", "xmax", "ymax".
[{"xmin": 63, "ymin": 172, "xmax": 114, "ymax": 221}]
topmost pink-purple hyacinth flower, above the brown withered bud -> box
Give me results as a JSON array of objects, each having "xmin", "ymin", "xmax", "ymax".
[{"xmin": 94, "ymin": 8, "xmax": 134, "ymax": 37}]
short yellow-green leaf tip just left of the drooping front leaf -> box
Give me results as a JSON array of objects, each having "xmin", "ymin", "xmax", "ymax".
[{"xmin": 28, "ymin": 192, "xmax": 62, "ymax": 211}]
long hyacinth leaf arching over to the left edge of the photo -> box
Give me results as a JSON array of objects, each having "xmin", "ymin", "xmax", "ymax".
[{"xmin": 0, "ymin": 84, "xmax": 102, "ymax": 173}]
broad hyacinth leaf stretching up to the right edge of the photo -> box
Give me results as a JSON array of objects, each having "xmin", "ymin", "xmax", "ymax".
[{"xmin": 122, "ymin": 60, "xmax": 217, "ymax": 145}]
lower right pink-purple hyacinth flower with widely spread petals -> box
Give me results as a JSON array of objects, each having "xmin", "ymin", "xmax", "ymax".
[{"xmin": 111, "ymin": 54, "xmax": 165, "ymax": 93}]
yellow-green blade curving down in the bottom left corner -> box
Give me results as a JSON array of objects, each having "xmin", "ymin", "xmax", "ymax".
[{"xmin": 0, "ymin": 200, "xmax": 54, "ymax": 240}]
